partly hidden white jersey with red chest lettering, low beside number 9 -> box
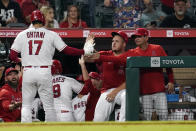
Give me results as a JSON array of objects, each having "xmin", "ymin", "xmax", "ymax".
[{"xmin": 72, "ymin": 94, "xmax": 89, "ymax": 121}]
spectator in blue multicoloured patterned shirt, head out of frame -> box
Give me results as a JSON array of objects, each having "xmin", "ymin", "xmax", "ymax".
[{"xmin": 104, "ymin": 0, "xmax": 150, "ymax": 28}]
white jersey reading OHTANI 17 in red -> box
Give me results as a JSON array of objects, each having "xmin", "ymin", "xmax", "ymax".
[{"xmin": 11, "ymin": 27, "xmax": 67, "ymax": 66}]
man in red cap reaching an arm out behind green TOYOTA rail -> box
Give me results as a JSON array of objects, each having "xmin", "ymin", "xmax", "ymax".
[{"xmin": 91, "ymin": 28, "xmax": 174, "ymax": 120}]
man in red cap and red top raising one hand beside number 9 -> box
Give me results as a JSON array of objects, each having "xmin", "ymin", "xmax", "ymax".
[{"xmin": 79, "ymin": 56, "xmax": 102, "ymax": 121}]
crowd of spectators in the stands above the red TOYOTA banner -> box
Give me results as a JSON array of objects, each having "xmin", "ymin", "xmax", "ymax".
[{"xmin": 0, "ymin": 0, "xmax": 196, "ymax": 28}]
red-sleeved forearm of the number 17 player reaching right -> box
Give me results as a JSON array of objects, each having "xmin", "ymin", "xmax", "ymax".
[{"xmin": 62, "ymin": 46, "xmax": 84, "ymax": 56}]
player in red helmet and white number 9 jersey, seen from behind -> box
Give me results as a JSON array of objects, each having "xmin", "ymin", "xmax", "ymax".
[{"xmin": 52, "ymin": 60, "xmax": 83, "ymax": 121}]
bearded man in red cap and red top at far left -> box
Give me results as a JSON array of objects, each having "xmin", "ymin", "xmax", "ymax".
[{"xmin": 0, "ymin": 68, "xmax": 22, "ymax": 122}]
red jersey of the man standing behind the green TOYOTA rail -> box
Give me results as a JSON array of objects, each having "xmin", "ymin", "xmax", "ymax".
[{"xmin": 134, "ymin": 44, "xmax": 174, "ymax": 95}]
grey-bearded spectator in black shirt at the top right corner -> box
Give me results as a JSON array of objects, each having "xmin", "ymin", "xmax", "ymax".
[{"xmin": 160, "ymin": 0, "xmax": 196, "ymax": 28}]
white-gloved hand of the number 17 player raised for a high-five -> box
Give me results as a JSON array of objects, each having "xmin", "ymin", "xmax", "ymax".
[{"xmin": 83, "ymin": 34, "xmax": 95, "ymax": 55}]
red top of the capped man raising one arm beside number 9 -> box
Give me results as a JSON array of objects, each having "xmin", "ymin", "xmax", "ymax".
[{"xmin": 80, "ymin": 79, "xmax": 101, "ymax": 121}]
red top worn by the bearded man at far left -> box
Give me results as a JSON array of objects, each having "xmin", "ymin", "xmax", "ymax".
[{"xmin": 0, "ymin": 84, "xmax": 22, "ymax": 122}]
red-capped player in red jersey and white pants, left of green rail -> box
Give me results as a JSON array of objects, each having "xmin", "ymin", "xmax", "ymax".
[{"xmin": 85, "ymin": 31, "xmax": 128, "ymax": 121}]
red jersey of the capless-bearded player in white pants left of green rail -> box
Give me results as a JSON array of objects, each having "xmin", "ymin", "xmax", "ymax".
[{"xmin": 97, "ymin": 50, "xmax": 125, "ymax": 92}]
